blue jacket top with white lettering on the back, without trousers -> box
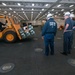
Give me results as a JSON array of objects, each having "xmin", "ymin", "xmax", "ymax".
[{"xmin": 42, "ymin": 18, "xmax": 57, "ymax": 38}]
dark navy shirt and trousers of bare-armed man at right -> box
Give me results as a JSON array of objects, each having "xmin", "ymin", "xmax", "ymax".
[{"xmin": 64, "ymin": 18, "xmax": 73, "ymax": 54}]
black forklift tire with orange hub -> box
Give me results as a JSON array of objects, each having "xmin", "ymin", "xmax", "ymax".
[{"xmin": 3, "ymin": 31, "xmax": 17, "ymax": 43}]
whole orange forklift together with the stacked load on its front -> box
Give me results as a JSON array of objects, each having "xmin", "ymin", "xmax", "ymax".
[{"xmin": 0, "ymin": 16, "xmax": 35, "ymax": 43}]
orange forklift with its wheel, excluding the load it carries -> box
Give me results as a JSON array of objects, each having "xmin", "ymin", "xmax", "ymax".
[{"xmin": 0, "ymin": 15, "xmax": 22, "ymax": 42}]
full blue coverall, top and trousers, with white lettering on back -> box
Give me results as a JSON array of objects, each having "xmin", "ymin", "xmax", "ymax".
[{"xmin": 42, "ymin": 18, "xmax": 57, "ymax": 56}]
